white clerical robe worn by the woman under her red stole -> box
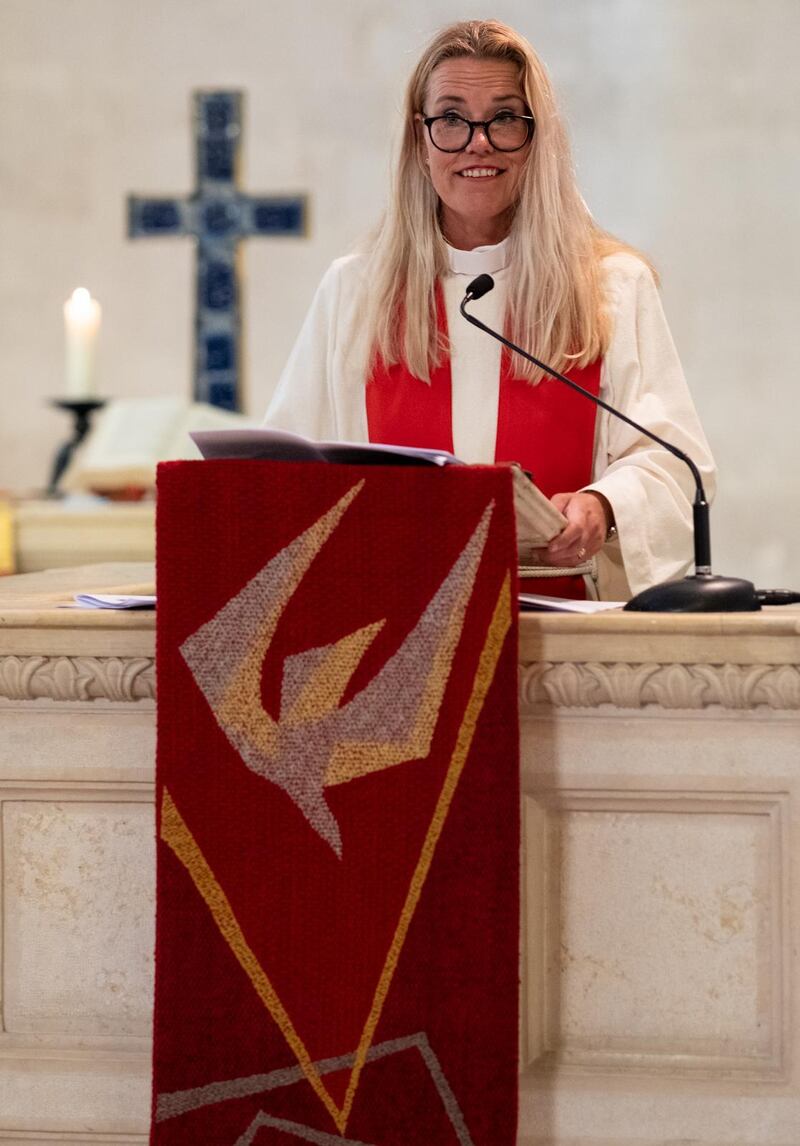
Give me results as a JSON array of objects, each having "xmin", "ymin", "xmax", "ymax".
[{"xmin": 265, "ymin": 242, "xmax": 714, "ymax": 601}]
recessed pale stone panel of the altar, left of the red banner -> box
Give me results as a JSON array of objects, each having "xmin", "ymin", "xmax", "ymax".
[{"xmin": 2, "ymin": 799, "xmax": 155, "ymax": 1038}]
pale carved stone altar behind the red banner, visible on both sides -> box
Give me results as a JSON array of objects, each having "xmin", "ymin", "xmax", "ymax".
[{"xmin": 0, "ymin": 564, "xmax": 800, "ymax": 1146}]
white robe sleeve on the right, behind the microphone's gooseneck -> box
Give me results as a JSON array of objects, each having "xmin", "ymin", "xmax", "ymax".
[{"xmin": 586, "ymin": 256, "xmax": 714, "ymax": 599}]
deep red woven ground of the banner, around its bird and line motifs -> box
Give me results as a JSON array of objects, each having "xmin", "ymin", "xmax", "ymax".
[{"xmin": 151, "ymin": 462, "xmax": 519, "ymax": 1146}]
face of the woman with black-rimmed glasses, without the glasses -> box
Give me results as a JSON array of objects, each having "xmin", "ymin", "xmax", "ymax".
[{"xmin": 417, "ymin": 57, "xmax": 531, "ymax": 250}]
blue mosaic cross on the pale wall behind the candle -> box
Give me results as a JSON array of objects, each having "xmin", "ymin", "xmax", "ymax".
[{"xmin": 128, "ymin": 92, "xmax": 306, "ymax": 410}]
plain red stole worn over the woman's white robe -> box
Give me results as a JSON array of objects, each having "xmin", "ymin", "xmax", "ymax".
[{"xmin": 367, "ymin": 290, "xmax": 602, "ymax": 597}]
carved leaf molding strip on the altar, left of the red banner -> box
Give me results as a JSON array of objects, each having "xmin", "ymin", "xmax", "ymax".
[{"xmin": 0, "ymin": 657, "xmax": 156, "ymax": 700}]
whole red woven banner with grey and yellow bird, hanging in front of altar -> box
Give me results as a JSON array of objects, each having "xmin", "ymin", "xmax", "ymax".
[{"xmin": 151, "ymin": 461, "xmax": 519, "ymax": 1146}]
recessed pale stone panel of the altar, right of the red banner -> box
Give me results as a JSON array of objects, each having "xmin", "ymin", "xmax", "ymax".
[{"xmin": 526, "ymin": 793, "xmax": 785, "ymax": 1074}]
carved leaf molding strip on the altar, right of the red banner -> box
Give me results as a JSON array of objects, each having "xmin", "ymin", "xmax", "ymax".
[{"xmin": 519, "ymin": 661, "xmax": 800, "ymax": 709}]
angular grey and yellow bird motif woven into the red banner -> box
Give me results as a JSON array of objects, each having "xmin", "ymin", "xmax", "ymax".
[{"xmin": 181, "ymin": 481, "xmax": 493, "ymax": 857}]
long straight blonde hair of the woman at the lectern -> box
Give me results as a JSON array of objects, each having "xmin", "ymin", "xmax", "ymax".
[{"xmin": 362, "ymin": 19, "xmax": 646, "ymax": 382}]
